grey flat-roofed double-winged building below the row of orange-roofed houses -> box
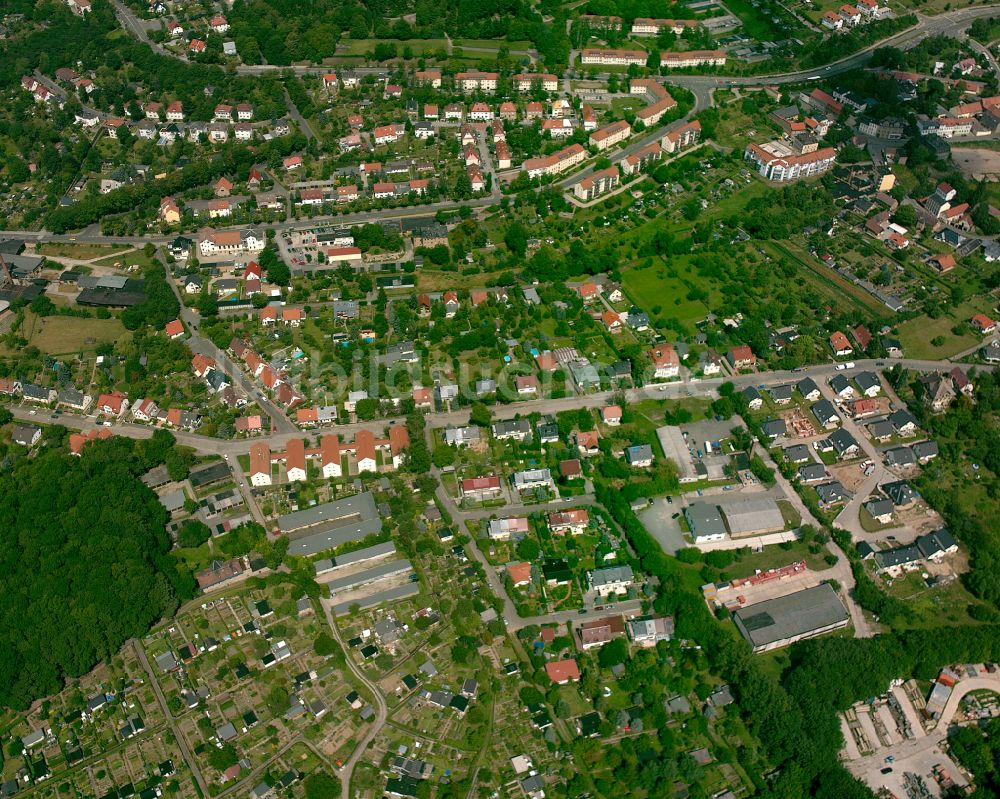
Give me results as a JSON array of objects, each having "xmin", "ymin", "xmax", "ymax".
[{"xmin": 278, "ymin": 491, "xmax": 382, "ymax": 556}]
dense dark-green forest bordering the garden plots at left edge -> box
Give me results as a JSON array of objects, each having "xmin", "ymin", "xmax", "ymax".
[{"xmin": 0, "ymin": 431, "xmax": 194, "ymax": 709}]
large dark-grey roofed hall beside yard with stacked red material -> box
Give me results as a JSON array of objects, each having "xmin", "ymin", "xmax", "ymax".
[{"xmin": 733, "ymin": 583, "xmax": 851, "ymax": 652}]
